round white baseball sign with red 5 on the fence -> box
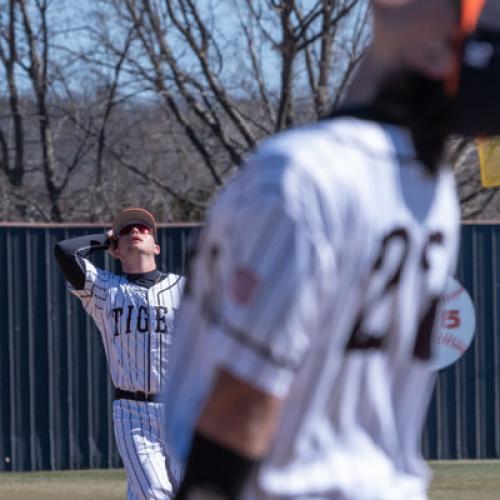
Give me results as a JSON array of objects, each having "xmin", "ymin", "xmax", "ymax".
[{"xmin": 432, "ymin": 277, "xmax": 476, "ymax": 370}]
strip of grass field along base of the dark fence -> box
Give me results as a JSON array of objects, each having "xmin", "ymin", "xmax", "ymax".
[{"xmin": 0, "ymin": 460, "xmax": 500, "ymax": 500}]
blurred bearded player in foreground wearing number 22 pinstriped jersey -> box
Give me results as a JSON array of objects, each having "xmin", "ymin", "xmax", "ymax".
[{"xmin": 165, "ymin": 0, "xmax": 498, "ymax": 500}]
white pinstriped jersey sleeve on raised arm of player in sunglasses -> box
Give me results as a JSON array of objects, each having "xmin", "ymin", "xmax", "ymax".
[{"xmin": 67, "ymin": 259, "xmax": 114, "ymax": 319}]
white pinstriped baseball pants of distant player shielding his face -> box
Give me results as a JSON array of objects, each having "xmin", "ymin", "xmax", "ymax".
[{"xmin": 113, "ymin": 399, "xmax": 180, "ymax": 500}]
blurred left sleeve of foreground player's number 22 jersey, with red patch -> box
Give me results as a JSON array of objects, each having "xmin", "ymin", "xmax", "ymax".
[{"xmin": 197, "ymin": 148, "xmax": 332, "ymax": 397}]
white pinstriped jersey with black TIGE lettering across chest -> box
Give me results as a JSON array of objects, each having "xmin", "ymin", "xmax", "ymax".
[{"xmin": 72, "ymin": 259, "xmax": 184, "ymax": 394}]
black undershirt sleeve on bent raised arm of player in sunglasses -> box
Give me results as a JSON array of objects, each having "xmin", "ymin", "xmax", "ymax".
[{"xmin": 54, "ymin": 233, "xmax": 109, "ymax": 290}]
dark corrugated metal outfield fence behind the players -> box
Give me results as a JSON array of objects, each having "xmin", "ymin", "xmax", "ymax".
[{"xmin": 0, "ymin": 224, "xmax": 500, "ymax": 471}]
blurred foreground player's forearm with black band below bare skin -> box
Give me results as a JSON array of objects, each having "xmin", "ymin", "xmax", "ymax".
[{"xmin": 176, "ymin": 371, "xmax": 282, "ymax": 500}]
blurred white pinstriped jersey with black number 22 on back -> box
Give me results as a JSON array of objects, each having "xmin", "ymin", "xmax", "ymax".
[{"xmin": 165, "ymin": 117, "xmax": 459, "ymax": 500}]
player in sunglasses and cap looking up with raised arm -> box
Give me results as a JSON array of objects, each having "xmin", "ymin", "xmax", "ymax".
[{"xmin": 55, "ymin": 208, "xmax": 184, "ymax": 499}]
